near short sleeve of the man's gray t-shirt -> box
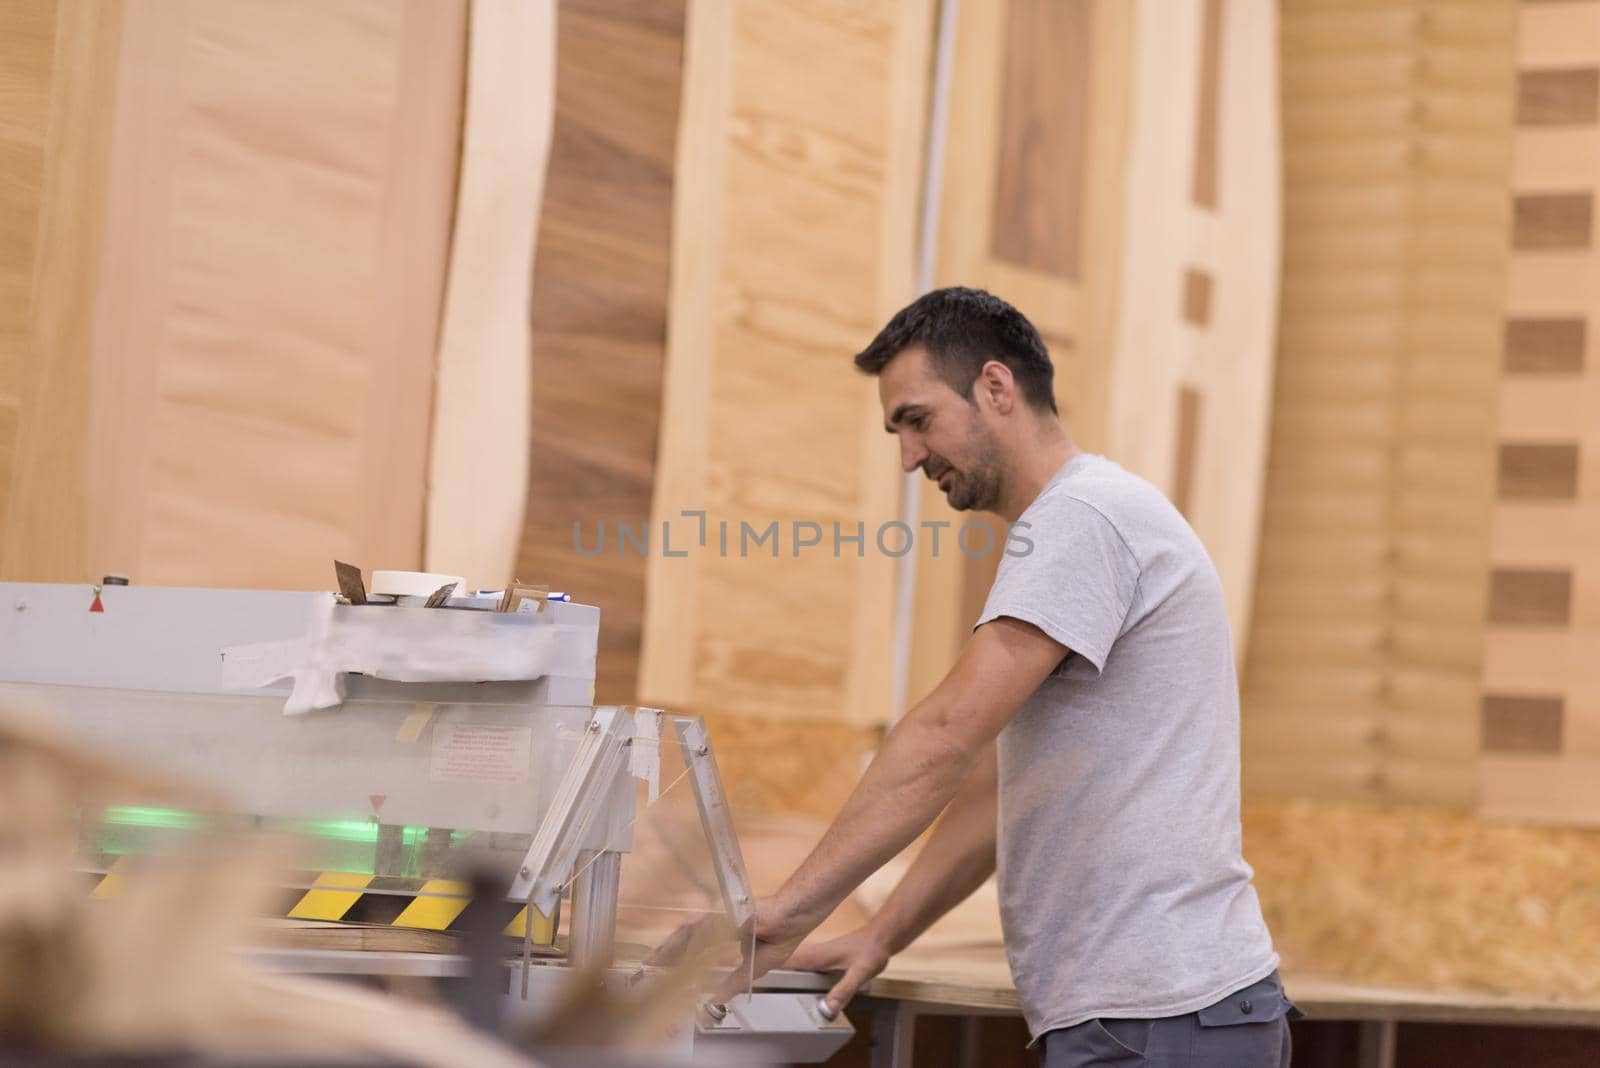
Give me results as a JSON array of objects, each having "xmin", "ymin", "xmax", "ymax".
[{"xmin": 973, "ymin": 494, "xmax": 1139, "ymax": 673}]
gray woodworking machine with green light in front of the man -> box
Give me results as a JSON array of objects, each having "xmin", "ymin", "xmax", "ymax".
[{"xmin": 0, "ymin": 579, "xmax": 851, "ymax": 1065}]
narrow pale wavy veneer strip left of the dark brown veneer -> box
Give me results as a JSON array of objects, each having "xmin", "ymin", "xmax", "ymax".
[{"xmin": 422, "ymin": 0, "xmax": 558, "ymax": 590}]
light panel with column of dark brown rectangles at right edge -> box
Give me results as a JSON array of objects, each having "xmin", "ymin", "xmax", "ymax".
[{"xmin": 1480, "ymin": 0, "xmax": 1600, "ymax": 823}]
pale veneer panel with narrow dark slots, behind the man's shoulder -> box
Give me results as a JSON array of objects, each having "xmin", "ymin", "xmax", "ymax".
[{"xmin": 1104, "ymin": 0, "xmax": 1291, "ymax": 654}]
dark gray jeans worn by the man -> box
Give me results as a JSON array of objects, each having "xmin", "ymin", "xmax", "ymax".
[{"xmin": 1045, "ymin": 972, "xmax": 1301, "ymax": 1068}]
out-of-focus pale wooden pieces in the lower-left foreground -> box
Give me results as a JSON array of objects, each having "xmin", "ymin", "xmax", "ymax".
[{"xmin": 0, "ymin": 726, "xmax": 533, "ymax": 1066}]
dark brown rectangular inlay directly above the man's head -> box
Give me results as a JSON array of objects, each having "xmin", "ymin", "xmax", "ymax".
[{"xmin": 992, "ymin": 0, "xmax": 1094, "ymax": 279}]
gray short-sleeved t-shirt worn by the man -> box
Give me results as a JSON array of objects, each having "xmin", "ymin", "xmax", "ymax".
[{"xmin": 978, "ymin": 454, "xmax": 1278, "ymax": 1038}]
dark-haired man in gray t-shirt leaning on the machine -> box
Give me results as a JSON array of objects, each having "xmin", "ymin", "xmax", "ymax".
[{"xmin": 713, "ymin": 288, "xmax": 1293, "ymax": 1068}]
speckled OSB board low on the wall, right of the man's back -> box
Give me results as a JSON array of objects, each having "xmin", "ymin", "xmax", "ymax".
[{"xmin": 1243, "ymin": 801, "xmax": 1600, "ymax": 1002}]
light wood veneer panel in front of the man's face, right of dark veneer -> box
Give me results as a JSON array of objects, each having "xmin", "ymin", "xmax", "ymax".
[{"xmin": 640, "ymin": 0, "xmax": 933, "ymax": 724}]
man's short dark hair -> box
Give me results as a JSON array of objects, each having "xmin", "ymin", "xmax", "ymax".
[{"xmin": 856, "ymin": 286, "xmax": 1056, "ymax": 412}]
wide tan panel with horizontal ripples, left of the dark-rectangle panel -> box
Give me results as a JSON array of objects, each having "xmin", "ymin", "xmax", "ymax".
[{"xmin": 1243, "ymin": 0, "xmax": 1517, "ymax": 804}]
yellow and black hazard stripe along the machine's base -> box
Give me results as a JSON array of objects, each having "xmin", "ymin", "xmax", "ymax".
[{"xmin": 91, "ymin": 857, "xmax": 560, "ymax": 945}]
